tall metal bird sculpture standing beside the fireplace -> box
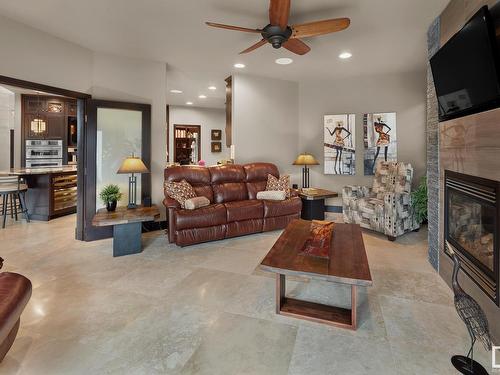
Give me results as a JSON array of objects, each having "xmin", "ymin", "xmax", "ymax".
[{"xmin": 451, "ymin": 251, "xmax": 491, "ymax": 375}]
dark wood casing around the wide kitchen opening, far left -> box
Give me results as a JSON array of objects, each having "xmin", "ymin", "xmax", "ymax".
[{"xmin": 0, "ymin": 75, "xmax": 92, "ymax": 240}]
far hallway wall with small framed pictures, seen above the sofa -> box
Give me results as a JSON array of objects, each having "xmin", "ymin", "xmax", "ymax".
[{"xmin": 169, "ymin": 106, "xmax": 230, "ymax": 166}]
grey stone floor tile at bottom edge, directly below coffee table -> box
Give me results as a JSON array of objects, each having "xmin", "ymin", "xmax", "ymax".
[{"xmin": 288, "ymin": 326, "xmax": 396, "ymax": 375}]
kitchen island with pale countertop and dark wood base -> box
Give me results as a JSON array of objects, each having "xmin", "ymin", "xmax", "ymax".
[{"xmin": 0, "ymin": 165, "xmax": 77, "ymax": 221}]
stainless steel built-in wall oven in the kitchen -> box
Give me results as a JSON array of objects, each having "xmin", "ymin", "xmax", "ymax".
[{"xmin": 26, "ymin": 139, "xmax": 63, "ymax": 168}]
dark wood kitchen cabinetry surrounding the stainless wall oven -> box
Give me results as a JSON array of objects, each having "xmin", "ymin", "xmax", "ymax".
[{"xmin": 21, "ymin": 95, "xmax": 77, "ymax": 166}]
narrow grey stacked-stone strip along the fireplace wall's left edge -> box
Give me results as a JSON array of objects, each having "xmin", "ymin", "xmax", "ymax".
[{"xmin": 426, "ymin": 18, "xmax": 441, "ymax": 271}]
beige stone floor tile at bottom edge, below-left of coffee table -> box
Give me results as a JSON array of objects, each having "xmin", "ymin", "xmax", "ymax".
[{"xmin": 181, "ymin": 313, "xmax": 297, "ymax": 375}]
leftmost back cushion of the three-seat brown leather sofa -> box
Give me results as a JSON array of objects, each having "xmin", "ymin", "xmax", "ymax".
[{"xmin": 164, "ymin": 165, "xmax": 214, "ymax": 202}]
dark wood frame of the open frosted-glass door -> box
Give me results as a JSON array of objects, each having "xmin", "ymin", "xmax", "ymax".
[{"xmin": 84, "ymin": 100, "xmax": 151, "ymax": 241}]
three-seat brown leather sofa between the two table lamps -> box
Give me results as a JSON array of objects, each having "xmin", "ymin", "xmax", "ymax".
[{"xmin": 163, "ymin": 163, "xmax": 302, "ymax": 246}]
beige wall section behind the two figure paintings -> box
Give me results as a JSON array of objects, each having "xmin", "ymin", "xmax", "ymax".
[{"xmin": 299, "ymin": 72, "xmax": 426, "ymax": 204}]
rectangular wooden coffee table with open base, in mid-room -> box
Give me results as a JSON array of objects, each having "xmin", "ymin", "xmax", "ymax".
[{"xmin": 260, "ymin": 219, "xmax": 372, "ymax": 330}]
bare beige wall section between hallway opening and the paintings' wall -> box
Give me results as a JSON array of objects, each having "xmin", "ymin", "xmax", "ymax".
[{"xmin": 233, "ymin": 74, "xmax": 300, "ymax": 183}]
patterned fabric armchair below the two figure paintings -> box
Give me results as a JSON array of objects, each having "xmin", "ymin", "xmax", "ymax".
[{"xmin": 342, "ymin": 161, "xmax": 419, "ymax": 241}]
